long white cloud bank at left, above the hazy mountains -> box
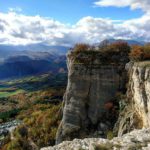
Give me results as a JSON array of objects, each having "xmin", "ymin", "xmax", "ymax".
[{"xmin": 0, "ymin": 12, "xmax": 69, "ymax": 44}]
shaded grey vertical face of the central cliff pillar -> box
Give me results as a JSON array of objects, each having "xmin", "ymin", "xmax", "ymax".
[{"xmin": 56, "ymin": 51, "xmax": 126, "ymax": 144}]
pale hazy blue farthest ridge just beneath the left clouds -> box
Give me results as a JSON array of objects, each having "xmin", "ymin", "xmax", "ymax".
[{"xmin": 0, "ymin": 43, "xmax": 69, "ymax": 61}]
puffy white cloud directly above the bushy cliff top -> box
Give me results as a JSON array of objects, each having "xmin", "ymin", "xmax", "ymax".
[{"xmin": 74, "ymin": 17, "xmax": 115, "ymax": 43}]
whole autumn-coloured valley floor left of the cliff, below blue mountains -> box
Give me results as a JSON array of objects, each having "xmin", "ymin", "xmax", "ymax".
[{"xmin": 0, "ymin": 73, "xmax": 67, "ymax": 150}]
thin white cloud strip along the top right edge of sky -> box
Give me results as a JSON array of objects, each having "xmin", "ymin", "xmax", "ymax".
[{"xmin": 94, "ymin": 0, "xmax": 150, "ymax": 12}]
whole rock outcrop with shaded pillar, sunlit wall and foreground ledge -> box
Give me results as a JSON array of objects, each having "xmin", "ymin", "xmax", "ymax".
[{"xmin": 42, "ymin": 49, "xmax": 150, "ymax": 150}]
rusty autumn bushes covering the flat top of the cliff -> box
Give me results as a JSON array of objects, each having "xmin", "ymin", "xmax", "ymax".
[{"xmin": 70, "ymin": 41, "xmax": 150, "ymax": 64}]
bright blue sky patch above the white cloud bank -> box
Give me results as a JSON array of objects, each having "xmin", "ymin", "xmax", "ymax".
[{"xmin": 0, "ymin": 0, "xmax": 143, "ymax": 24}]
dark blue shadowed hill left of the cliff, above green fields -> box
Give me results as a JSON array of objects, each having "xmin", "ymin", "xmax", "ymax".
[{"xmin": 0, "ymin": 52, "xmax": 67, "ymax": 79}]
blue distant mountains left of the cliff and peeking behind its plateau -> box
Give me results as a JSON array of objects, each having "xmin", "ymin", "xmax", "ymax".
[{"xmin": 0, "ymin": 39, "xmax": 145, "ymax": 79}]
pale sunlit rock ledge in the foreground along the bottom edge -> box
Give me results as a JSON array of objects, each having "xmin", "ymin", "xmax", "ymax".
[{"xmin": 41, "ymin": 128, "xmax": 150, "ymax": 150}]
